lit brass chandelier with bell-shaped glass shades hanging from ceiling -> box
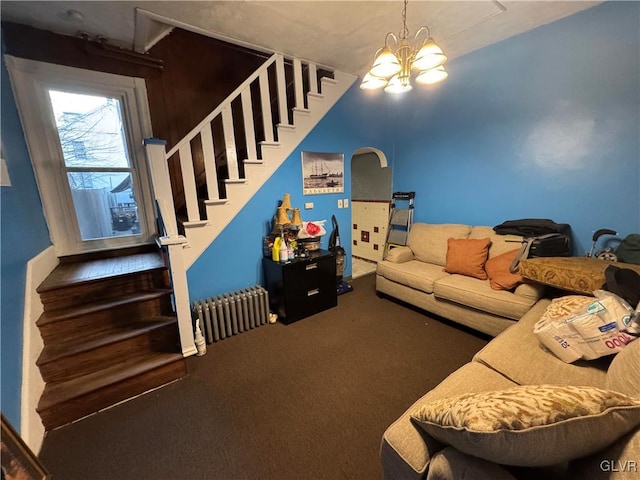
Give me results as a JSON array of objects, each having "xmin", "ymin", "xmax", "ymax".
[{"xmin": 360, "ymin": 0, "xmax": 449, "ymax": 93}]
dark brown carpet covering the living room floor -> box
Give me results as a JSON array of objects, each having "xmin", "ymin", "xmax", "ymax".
[{"xmin": 40, "ymin": 275, "xmax": 487, "ymax": 480}]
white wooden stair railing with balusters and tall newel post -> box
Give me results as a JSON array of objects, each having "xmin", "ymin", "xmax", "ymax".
[{"xmin": 145, "ymin": 53, "xmax": 320, "ymax": 356}]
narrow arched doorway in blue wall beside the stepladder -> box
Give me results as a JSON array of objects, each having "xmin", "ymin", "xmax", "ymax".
[{"xmin": 351, "ymin": 147, "xmax": 392, "ymax": 278}]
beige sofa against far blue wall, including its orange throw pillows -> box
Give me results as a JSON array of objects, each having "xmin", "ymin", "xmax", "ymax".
[{"xmin": 376, "ymin": 223, "xmax": 544, "ymax": 336}]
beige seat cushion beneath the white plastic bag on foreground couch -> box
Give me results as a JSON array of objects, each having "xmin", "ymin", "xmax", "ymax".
[{"xmin": 473, "ymin": 299, "xmax": 610, "ymax": 388}]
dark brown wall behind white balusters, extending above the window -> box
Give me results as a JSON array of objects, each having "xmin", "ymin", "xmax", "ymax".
[{"xmin": 2, "ymin": 22, "xmax": 332, "ymax": 223}]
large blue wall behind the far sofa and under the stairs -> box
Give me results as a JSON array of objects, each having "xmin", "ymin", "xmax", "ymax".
[{"xmin": 188, "ymin": 2, "xmax": 640, "ymax": 299}]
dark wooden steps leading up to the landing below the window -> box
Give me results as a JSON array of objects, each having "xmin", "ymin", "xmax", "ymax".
[{"xmin": 36, "ymin": 245, "xmax": 186, "ymax": 430}]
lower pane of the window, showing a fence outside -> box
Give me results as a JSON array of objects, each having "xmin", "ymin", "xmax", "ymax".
[{"xmin": 67, "ymin": 172, "xmax": 140, "ymax": 240}]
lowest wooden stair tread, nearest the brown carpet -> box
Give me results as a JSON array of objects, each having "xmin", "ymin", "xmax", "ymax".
[{"xmin": 37, "ymin": 353, "xmax": 184, "ymax": 412}]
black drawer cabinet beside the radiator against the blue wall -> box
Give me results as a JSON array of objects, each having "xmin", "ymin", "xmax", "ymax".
[{"xmin": 263, "ymin": 250, "xmax": 338, "ymax": 323}]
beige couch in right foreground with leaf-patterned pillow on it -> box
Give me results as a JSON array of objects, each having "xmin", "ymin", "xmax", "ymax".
[{"xmin": 381, "ymin": 299, "xmax": 640, "ymax": 480}]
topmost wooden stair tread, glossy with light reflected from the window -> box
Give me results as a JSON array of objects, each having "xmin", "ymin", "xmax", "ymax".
[{"xmin": 37, "ymin": 252, "xmax": 166, "ymax": 293}]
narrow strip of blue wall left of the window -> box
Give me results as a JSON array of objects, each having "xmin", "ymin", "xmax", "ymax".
[{"xmin": 0, "ymin": 37, "xmax": 51, "ymax": 430}]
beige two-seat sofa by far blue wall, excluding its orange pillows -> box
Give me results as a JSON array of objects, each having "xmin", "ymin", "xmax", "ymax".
[{"xmin": 376, "ymin": 223, "xmax": 544, "ymax": 336}]
